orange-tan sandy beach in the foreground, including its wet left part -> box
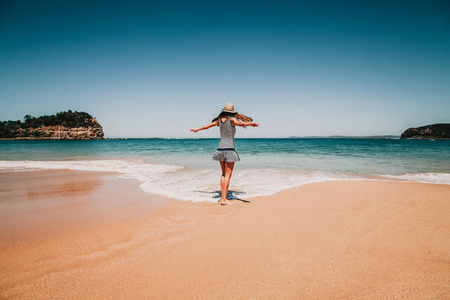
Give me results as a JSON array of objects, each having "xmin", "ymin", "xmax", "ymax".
[{"xmin": 0, "ymin": 170, "xmax": 450, "ymax": 299}]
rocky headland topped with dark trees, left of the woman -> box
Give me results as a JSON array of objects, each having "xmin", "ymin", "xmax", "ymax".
[{"xmin": 0, "ymin": 110, "xmax": 104, "ymax": 140}]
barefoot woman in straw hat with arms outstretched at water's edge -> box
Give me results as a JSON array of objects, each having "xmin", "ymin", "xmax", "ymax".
[{"xmin": 191, "ymin": 103, "xmax": 259, "ymax": 205}]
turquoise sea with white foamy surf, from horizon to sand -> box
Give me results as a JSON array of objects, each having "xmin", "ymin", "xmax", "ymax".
[{"xmin": 0, "ymin": 138, "xmax": 450, "ymax": 201}]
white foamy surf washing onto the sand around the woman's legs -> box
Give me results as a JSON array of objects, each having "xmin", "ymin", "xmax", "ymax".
[{"xmin": 0, "ymin": 159, "xmax": 450, "ymax": 202}]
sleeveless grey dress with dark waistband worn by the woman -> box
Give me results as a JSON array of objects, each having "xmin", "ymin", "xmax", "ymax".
[{"xmin": 212, "ymin": 117, "xmax": 240, "ymax": 162}]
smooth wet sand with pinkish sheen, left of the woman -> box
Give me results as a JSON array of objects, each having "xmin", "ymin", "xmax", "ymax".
[{"xmin": 0, "ymin": 170, "xmax": 171, "ymax": 248}]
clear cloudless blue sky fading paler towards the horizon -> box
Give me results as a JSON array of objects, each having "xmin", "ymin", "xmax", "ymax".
[{"xmin": 0, "ymin": 0, "xmax": 450, "ymax": 137}]
